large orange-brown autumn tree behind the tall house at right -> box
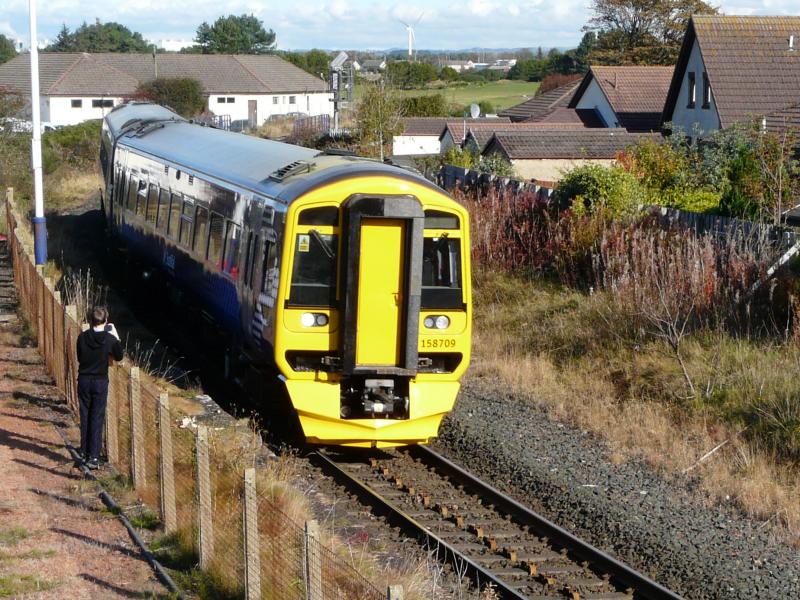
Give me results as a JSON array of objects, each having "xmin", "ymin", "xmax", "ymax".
[{"xmin": 584, "ymin": 0, "xmax": 717, "ymax": 65}]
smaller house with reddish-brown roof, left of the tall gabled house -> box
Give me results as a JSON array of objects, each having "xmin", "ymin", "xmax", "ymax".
[{"xmin": 568, "ymin": 66, "xmax": 674, "ymax": 132}]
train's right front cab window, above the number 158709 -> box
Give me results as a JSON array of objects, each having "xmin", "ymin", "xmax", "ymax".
[{"xmin": 421, "ymin": 236, "xmax": 464, "ymax": 308}]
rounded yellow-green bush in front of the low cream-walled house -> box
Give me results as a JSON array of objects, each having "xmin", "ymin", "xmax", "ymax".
[{"xmin": 554, "ymin": 165, "xmax": 646, "ymax": 216}]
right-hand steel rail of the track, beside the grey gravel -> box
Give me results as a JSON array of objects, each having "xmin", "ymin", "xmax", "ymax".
[{"xmin": 408, "ymin": 446, "xmax": 682, "ymax": 600}]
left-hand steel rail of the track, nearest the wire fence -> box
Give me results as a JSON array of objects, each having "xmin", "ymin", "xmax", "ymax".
[{"xmin": 309, "ymin": 451, "xmax": 528, "ymax": 600}]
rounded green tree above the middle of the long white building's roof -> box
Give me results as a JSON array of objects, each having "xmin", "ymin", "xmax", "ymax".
[{"xmin": 194, "ymin": 15, "xmax": 275, "ymax": 54}]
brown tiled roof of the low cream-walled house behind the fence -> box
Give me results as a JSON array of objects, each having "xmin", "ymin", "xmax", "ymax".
[{"xmin": 484, "ymin": 128, "xmax": 662, "ymax": 160}]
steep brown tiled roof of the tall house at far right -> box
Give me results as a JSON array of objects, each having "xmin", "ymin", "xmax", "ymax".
[{"xmin": 664, "ymin": 15, "xmax": 800, "ymax": 128}]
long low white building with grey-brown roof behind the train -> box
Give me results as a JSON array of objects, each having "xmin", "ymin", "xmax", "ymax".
[{"xmin": 0, "ymin": 52, "xmax": 333, "ymax": 126}]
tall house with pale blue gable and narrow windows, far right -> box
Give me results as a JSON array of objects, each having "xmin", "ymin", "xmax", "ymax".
[{"xmin": 662, "ymin": 15, "xmax": 800, "ymax": 135}]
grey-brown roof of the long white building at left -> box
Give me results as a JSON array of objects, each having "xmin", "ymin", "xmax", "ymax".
[{"xmin": 0, "ymin": 52, "xmax": 327, "ymax": 96}]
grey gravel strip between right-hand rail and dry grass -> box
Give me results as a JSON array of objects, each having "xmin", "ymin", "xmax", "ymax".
[{"xmin": 436, "ymin": 384, "xmax": 800, "ymax": 600}]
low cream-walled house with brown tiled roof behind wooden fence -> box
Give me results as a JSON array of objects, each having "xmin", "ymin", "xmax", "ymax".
[{"xmin": 482, "ymin": 127, "xmax": 662, "ymax": 181}]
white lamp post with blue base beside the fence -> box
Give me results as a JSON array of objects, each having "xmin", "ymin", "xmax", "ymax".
[{"xmin": 28, "ymin": 0, "xmax": 47, "ymax": 265}]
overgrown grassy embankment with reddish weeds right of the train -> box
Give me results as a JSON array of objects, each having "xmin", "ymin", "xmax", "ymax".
[{"xmin": 462, "ymin": 189, "xmax": 800, "ymax": 540}]
